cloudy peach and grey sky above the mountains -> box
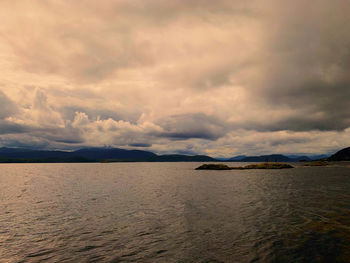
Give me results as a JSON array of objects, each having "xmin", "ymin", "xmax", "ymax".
[{"xmin": 0, "ymin": 0, "xmax": 350, "ymax": 157}]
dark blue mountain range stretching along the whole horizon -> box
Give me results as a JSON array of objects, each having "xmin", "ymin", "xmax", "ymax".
[{"xmin": 0, "ymin": 147, "xmax": 350, "ymax": 163}]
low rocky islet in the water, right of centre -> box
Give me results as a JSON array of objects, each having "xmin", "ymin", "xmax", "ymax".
[{"xmin": 196, "ymin": 163, "xmax": 294, "ymax": 170}]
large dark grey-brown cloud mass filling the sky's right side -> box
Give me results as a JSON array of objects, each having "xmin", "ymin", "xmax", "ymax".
[{"xmin": 256, "ymin": 0, "xmax": 350, "ymax": 131}]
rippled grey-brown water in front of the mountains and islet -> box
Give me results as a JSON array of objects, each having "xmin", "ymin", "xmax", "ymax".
[{"xmin": 0, "ymin": 163, "xmax": 350, "ymax": 262}]
